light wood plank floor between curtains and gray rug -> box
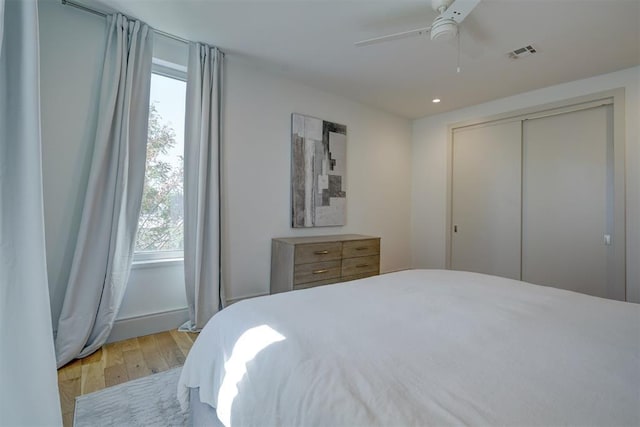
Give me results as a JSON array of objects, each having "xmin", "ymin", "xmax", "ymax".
[{"xmin": 58, "ymin": 331, "xmax": 197, "ymax": 427}]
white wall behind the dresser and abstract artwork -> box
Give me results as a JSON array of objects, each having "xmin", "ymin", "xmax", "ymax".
[{"xmin": 223, "ymin": 55, "xmax": 411, "ymax": 299}]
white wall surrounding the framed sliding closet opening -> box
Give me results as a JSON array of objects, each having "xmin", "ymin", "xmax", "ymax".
[{"xmin": 411, "ymin": 67, "xmax": 640, "ymax": 302}]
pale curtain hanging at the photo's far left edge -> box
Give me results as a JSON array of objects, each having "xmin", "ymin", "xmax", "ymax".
[{"xmin": 0, "ymin": 0, "xmax": 62, "ymax": 426}]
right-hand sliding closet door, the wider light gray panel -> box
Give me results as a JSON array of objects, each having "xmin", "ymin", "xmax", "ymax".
[{"xmin": 522, "ymin": 105, "xmax": 612, "ymax": 297}]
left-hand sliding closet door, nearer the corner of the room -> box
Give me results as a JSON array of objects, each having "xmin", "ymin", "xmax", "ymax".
[{"xmin": 450, "ymin": 121, "xmax": 521, "ymax": 279}]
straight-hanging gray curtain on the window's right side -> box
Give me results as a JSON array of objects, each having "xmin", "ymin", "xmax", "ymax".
[{"xmin": 180, "ymin": 43, "xmax": 224, "ymax": 331}]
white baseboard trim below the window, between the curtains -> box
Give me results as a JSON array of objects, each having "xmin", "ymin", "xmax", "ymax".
[{"xmin": 107, "ymin": 307, "xmax": 189, "ymax": 343}]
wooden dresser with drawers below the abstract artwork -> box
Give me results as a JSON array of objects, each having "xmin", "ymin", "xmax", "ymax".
[{"xmin": 271, "ymin": 234, "xmax": 380, "ymax": 294}]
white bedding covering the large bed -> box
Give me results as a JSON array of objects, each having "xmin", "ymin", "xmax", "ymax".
[{"xmin": 178, "ymin": 270, "xmax": 640, "ymax": 426}]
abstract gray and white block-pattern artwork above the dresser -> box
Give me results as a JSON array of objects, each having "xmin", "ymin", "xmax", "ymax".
[{"xmin": 291, "ymin": 113, "xmax": 347, "ymax": 228}]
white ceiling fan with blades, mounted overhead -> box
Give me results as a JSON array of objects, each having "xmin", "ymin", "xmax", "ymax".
[{"xmin": 355, "ymin": 0, "xmax": 480, "ymax": 47}]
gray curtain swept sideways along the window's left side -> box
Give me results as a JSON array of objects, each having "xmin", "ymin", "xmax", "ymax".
[{"xmin": 55, "ymin": 14, "xmax": 153, "ymax": 366}]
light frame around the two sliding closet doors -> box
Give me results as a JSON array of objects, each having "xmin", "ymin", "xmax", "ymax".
[{"xmin": 445, "ymin": 88, "xmax": 627, "ymax": 301}]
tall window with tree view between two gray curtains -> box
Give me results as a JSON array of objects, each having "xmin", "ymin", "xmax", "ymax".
[{"xmin": 134, "ymin": 60, "xmax": 186, "ymax": 262}]
